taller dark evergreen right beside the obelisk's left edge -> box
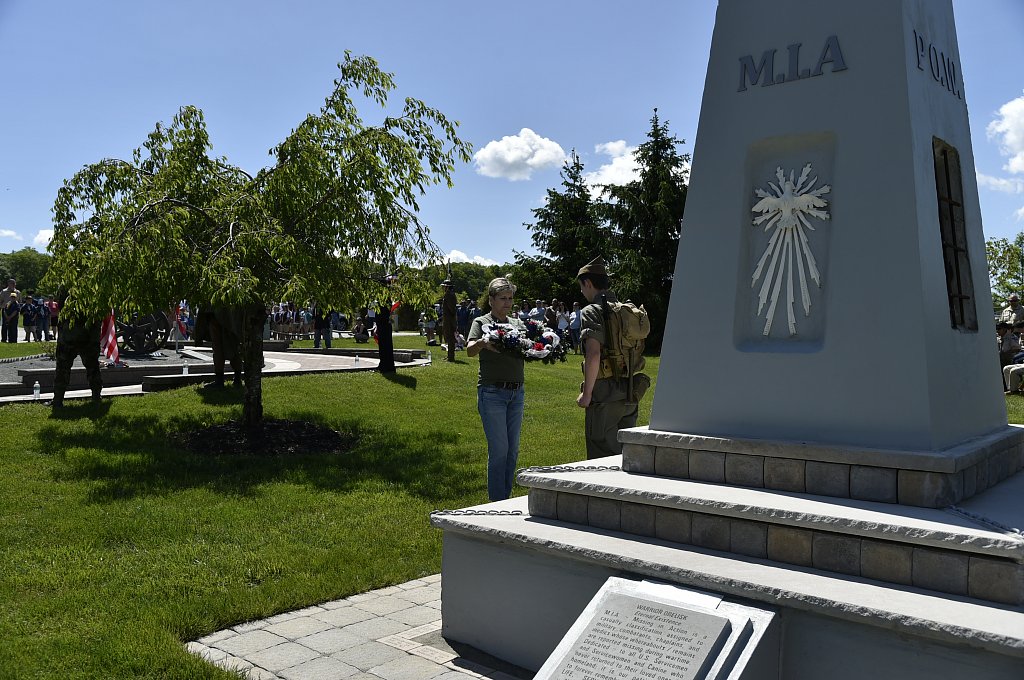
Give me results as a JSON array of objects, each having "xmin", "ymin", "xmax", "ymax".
[{"xmin": 603, "ymin": 109, "xmax": 690, "ymax": 349}]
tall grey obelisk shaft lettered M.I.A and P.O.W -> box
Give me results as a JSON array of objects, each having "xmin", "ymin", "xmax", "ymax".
[{"xmin": 629, "ymin": 0, "xmax": 1017, "ymax": 506}]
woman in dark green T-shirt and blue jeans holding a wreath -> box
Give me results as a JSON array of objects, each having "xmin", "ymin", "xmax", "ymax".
[{"xmin": 466, "ymin": 278, "xmax": 526, "ymax": 501}]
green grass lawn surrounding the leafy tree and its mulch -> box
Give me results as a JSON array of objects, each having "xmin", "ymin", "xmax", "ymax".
[{"xmin": 0, "ymin": 348, "xmax": 658, "ymax": 678}]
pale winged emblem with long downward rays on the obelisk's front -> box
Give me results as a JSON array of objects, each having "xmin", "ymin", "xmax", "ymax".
[{"xmin": 751, "ymin": 163, "xmax": 831, "ymax": 336}]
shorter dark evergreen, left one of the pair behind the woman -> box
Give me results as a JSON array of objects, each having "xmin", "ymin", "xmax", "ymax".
[{"xmin": 516, "ymin": 150, "xmax": 612, "ymax": 306}]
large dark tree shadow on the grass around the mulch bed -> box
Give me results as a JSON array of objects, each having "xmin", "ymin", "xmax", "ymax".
[{"xmin": 39, "ymin": 405, "xmax": 484, "ymax": 503}]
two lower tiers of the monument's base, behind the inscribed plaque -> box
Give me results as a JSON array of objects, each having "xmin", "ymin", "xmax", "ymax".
[{"xmin": 432, "ymin": 459, "xmax": 1024, "ymax": 680}]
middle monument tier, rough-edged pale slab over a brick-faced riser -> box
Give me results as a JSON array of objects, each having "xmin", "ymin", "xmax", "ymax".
[{"xmin": 518, "ymin": 457, "xmax": 1024, "ymax": 605}]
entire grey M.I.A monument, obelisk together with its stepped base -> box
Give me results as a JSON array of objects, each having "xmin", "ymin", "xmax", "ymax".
[{"xmin": 433, "ymin": 0, "xmax": 1024, "ymax": 680}]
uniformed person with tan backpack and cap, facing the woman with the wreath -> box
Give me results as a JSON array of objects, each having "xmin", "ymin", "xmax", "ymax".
[{"xmin": 577, "ymin": 256, "xmax": 649, "ymax": 459}]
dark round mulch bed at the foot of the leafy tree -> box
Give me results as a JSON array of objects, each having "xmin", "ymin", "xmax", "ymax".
[{"xmin": 177, "ymin": 419, "xmax": 355, "ymax": 456}]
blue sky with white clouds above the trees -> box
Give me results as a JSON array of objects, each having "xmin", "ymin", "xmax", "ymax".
[{"xmin": 0, "ymin": 0, "xmax": 1024, "ymax": 262}]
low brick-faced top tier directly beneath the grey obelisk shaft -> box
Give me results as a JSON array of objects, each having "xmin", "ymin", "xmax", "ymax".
[{"xmin": 618, "ymin": 425, "xmax": 1024, "ymax": 508}]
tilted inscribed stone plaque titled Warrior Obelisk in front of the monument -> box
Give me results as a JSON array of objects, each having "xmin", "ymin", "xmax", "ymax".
[{"xmin": 536, "ymin": 579, "xmax": 733, "ymax": 680}]
